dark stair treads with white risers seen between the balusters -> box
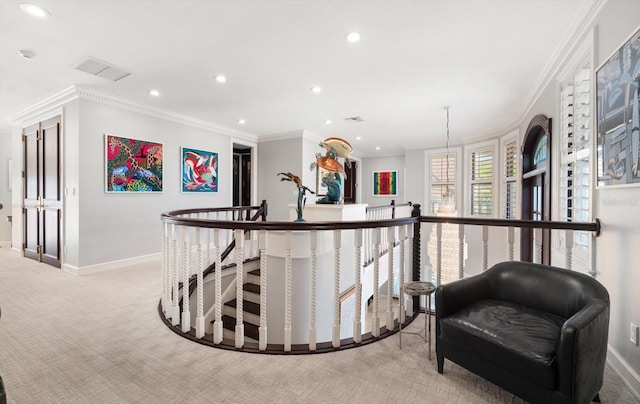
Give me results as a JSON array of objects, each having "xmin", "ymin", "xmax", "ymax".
[{"xmin": 222, "ymin": 268, "xmax": 260, "ymax": 343}]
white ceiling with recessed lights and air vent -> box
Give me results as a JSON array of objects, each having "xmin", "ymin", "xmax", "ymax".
[{"xmin": 0, "ymin": 0, "xmax": 593, "ymax": 156}]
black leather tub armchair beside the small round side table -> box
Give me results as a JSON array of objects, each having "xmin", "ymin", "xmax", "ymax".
[{"xmin": 436, "ymin": 261, "xmax": 609, "ymax": 404}]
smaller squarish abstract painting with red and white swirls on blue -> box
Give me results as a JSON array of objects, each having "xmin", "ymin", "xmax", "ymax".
[{"xmin": 182, "ymin": 147, "xmax": 218, "ymax": 192}]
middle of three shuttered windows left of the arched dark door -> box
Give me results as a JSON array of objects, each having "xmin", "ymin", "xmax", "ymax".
[{"xmin": 471, "ymin": 149, "xmax": 493, "ymax": 216}]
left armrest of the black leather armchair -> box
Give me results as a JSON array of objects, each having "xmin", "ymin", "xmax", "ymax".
[{"xmin": 436, "ymin": 274, "xmax": 490, "ymax": 320}]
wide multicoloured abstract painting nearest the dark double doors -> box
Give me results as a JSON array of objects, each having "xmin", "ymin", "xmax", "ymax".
[{"xmin": 105, "ymin": 135, "xmax": 163, "ymax": 193}]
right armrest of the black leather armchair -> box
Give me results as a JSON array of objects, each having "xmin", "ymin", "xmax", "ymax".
[{"xmin": 557, "ymin": 299, "xmax": 609, "ymax": 402}]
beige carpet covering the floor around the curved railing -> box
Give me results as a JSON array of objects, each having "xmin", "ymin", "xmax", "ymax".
[{"xmin": 0, "ymin": 248, "xmax": 638, "ymax": 404}]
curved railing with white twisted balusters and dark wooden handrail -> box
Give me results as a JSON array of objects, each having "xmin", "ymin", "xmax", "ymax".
[{"xmin": 159, "ymin": 202, "xmax": 600, "ymax": 353}]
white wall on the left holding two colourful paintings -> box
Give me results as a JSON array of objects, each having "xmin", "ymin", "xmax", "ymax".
[{"xmin": 70, "ymin": 99, "xmax": 232, "ymax": 269}]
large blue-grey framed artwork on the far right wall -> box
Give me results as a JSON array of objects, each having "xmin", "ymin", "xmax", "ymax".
[{"xmin": 596, "ymin": 29, "xmax": 640, "ymax": 186}]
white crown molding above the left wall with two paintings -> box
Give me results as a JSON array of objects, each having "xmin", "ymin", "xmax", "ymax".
[{"xmin": 9, "ymin": 85, "xmax": 258, "ymax": 143}]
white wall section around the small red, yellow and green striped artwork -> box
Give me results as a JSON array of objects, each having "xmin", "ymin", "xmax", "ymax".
[{"xmin": 360, "ymin": 156, "xmax": 404, "ymax": 206}]
